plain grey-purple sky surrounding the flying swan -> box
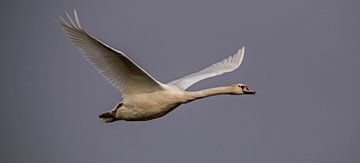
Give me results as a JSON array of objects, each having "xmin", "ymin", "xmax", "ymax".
[{"xmin": 0, "ymin": 0, "xmax": 360, "ymax": 163}]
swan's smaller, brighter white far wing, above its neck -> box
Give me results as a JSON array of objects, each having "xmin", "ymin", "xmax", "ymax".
[{"xmin": 168, "ymin": 47, "xmax": 245, "ymax": 90}]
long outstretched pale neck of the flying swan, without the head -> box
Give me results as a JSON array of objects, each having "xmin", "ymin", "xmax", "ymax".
[{"xmin": 186, "ymin": 87, "xmax": 231, "ymax": 102}]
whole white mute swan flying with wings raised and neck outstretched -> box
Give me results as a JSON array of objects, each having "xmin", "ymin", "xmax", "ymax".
[{"xmin": 58, "ymin": 10, "xmax": 255, "ymax": 123}]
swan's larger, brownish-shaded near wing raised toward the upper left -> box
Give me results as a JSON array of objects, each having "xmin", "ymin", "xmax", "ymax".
[{"xmin": 58, "ymin": 10, "xmax": 163, "ymax": 96}]
